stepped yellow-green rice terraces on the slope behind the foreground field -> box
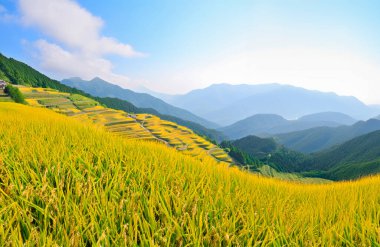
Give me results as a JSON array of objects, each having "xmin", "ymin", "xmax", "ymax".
[{"xmin": 19, "ymin": 86, "xmax": 232, "ymax": 163}]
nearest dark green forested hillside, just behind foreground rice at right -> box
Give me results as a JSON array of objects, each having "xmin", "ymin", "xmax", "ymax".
[{"xmin": 226, "ymin": 130, "xmax": 380, "ymax": 180}]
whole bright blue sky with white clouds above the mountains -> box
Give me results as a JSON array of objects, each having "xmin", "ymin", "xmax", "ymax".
[{"xmin": 0, "ymin": 0, "xmax": 380, "ymax": 104}]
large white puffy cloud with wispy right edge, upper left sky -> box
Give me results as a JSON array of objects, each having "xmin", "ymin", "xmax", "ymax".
[{"xmin": 19, "ymin": 0, "xmax": 144, "ymax": 87}]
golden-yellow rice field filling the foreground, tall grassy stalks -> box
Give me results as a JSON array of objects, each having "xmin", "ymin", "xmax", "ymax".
[{"xmin": 0, "ymin": 103, "xmax": 380, "ymax": 246}]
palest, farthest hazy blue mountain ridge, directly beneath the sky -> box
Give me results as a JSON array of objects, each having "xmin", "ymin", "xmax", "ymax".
[{"xmin": 157, "ymin": 84, "xmax": 379, "ymax": 126}]
